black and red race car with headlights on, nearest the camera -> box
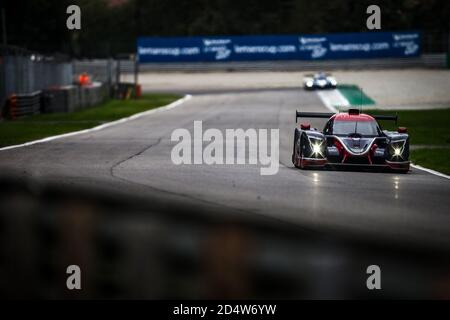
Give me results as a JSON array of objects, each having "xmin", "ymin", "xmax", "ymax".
[{"xmin": 292, "ymin": 109, "xmax": 410, "ymax": 172}]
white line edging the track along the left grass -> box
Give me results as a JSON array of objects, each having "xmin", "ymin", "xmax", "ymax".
[{"xmin": 0, "ymin": 94, "xmax": 192, "ymax": 151}]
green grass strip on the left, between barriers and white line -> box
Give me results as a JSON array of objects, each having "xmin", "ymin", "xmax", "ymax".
[{"xmin": 0, "ymin": 94, "xmax": 180, "ymax": 147}]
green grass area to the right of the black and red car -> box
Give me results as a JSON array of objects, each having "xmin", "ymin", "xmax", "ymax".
[{"xmin": 364, "ymin": 109, "xmax": 450, "ymax": 174}]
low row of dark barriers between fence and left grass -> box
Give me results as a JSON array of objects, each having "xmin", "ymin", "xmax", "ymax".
[{"xmin": 2, "ymin": 82, "xmax": 109, "ymax": 119}]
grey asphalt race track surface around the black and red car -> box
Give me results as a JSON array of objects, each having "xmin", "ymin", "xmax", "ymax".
[{"xmin": 0, "ymin": 89, "xmax": 450, "ymax": 246}]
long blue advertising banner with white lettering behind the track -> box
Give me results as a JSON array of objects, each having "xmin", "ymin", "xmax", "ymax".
[{"xmin": 137, "ymin": 31, "xmax": 421, "ymax": 63}]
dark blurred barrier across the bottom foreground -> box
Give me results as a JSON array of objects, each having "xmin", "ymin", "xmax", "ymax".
[{"xmin": 0, "ymin": 176, "xmax": 450, "ymax": 299}]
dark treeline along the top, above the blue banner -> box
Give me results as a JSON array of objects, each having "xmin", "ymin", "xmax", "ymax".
[{"xmin": 3, "ymin": 0, "xmax": 450, "ymax": 57}]
